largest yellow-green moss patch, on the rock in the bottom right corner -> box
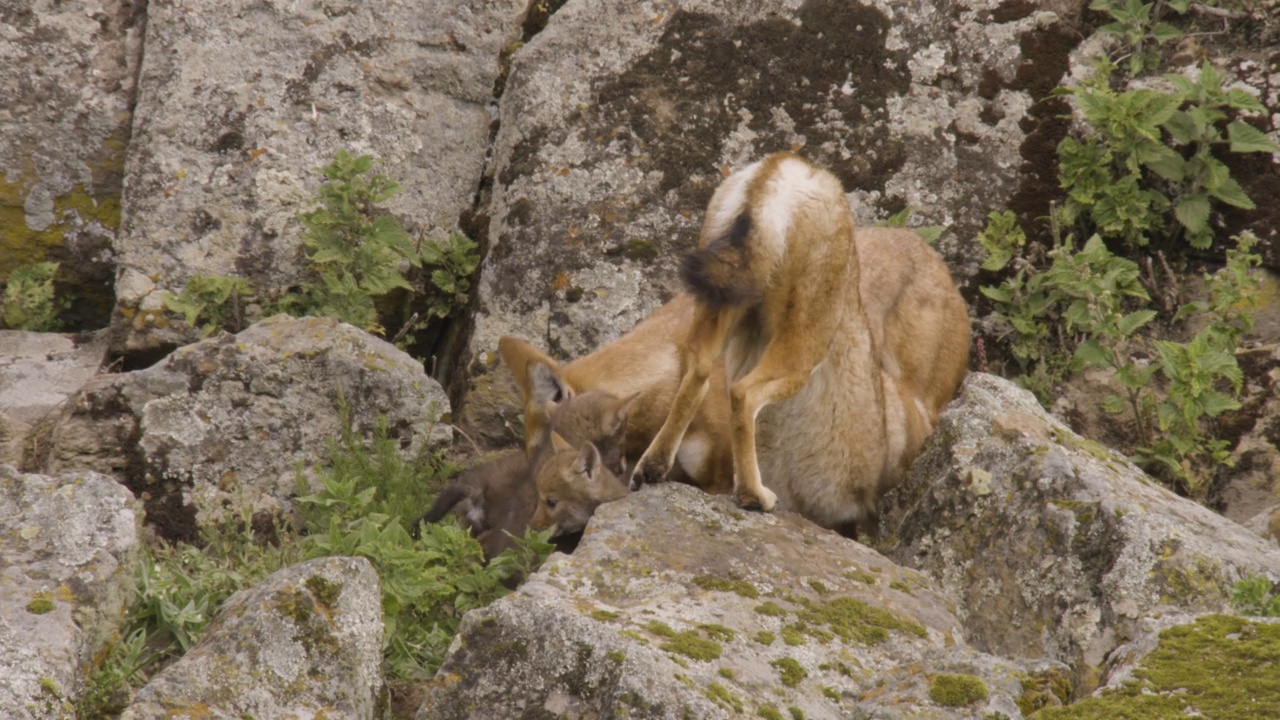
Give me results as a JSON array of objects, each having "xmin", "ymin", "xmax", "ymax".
[{"xmin": 1034, "ymin": 615, "xmax": 1280, "ymax": 720}]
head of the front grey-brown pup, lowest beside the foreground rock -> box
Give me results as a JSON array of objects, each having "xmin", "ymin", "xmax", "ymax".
[{"xmin": 529, "ymin": 434, "xmax": 630, "ymax": 538}]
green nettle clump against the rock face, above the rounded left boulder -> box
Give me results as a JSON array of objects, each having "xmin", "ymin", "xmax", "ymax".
[{"xmin": 165, "ymin": 150, "xmax": 480, "ymax": 337}]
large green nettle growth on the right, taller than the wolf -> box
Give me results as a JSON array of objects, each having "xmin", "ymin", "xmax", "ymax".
[{"xmin": 979, "ymin": 0, "xmax": 1280, "ymax": 497}]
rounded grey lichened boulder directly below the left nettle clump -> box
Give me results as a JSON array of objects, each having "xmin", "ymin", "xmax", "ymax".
[{"xmin": 45, "ymin": 315, "xmax": 452, "ymax": 541}]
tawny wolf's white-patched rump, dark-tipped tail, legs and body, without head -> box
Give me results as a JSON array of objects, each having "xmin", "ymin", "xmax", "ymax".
[{"xmin": 631, "ymin": 152, "xmax": 969, "ymax": 530}]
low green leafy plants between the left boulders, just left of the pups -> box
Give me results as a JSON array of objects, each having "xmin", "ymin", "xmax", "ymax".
[{"xmin": 78, "ymin": 412, "xmax": 552, "ymax": 719}]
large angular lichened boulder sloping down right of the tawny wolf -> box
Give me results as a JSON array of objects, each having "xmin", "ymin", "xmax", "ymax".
[{"xmin": 878, "ymin": 373, "xmax": 1280, "ymax": 683}]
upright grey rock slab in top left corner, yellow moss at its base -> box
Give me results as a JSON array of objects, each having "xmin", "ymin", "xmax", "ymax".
[{"xmin": 0, "ymin": 0, "xmax": 146, "ymax": 327}]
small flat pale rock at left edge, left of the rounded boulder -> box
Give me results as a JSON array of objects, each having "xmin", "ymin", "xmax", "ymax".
[{"xmin": 0, "ymin": 331, "xmax": 108, "ymax": 468}]
